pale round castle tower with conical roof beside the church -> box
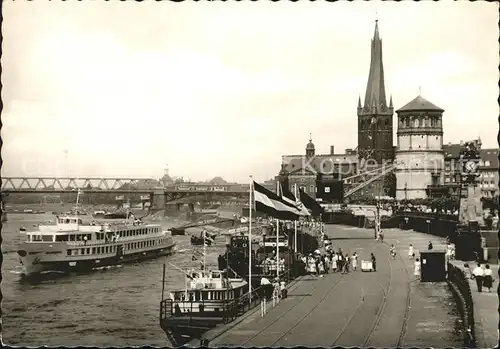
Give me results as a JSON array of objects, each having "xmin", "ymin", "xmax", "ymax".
[{"xmin": 395, "ymin": 95, "xmax": 444, "ymax": 200}]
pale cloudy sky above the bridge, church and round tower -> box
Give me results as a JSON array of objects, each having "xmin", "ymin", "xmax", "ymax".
[{"xmin": 1, "ymin": 1, "xmax": 499, "ymax": 183}]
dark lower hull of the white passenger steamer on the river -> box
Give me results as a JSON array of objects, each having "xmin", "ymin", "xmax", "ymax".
[{"xmin": 18, "ymin": 244, "xmax": 176, "ymax": 277}]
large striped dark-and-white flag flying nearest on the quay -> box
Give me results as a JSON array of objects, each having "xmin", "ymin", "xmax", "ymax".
[{"xmin": 253, "ymin": 182, "xmax": 299, "ymax": 221}]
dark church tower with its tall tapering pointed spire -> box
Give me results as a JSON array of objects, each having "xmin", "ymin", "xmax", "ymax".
[{"xmin": 358, "ymin": 20, "xmax": 394, "ymax": 164}]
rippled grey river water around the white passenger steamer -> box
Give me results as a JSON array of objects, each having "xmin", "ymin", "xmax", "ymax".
[{"xmin": 2, "ymin": 209, "xmax": 225, "ymax": 346}]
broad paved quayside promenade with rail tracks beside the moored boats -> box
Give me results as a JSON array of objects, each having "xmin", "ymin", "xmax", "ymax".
[{"xmin": 205, "ymin": 225, "xmax": 463, "ymax": 347}]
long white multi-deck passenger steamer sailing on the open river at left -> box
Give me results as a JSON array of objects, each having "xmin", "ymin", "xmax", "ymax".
[{"xmin": 17, "ymin": 192, "xmax": 176, "ymax": 276}]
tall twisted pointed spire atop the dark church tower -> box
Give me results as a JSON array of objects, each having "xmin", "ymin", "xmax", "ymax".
[{"xmin": 364, "ymin": 19, "xmax": 387, "ymax": 109}]
